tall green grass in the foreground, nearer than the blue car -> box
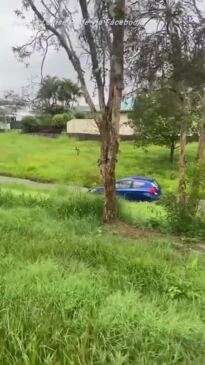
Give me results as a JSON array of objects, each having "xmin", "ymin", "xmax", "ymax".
[{"xmin": 0, "ymin": 187, "xmax": 205, "ymax": 365}]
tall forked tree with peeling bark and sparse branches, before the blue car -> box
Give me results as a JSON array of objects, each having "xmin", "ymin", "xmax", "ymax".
[{"xmin": 14, "ymin": 0, "xmax": 126, "ymax": 223}]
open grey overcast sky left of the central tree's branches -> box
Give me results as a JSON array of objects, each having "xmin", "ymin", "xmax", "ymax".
[{"xmin": 0, "ymin": 0, "xmax": 76, "ymax": 96}]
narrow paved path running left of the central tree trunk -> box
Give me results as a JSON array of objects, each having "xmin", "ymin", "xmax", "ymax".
[{"xmin": 0, "ymin": 176, "xmax": 88, "ymax": 192}]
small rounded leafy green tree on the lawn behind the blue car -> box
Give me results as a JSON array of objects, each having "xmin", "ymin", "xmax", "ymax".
[{"xmin": 130, "ymin": 84, "xmax": 193, "ymax": 162}]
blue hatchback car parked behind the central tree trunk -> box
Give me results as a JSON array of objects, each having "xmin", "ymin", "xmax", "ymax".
[{"xmin": 91, "ymin": 177, "xmax": 162, "ymax": 202}]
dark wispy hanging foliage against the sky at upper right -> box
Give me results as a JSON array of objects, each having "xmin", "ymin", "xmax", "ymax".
[{"xmin": 127, "ymin": 0, "xmax": 205, "ymax": 90}]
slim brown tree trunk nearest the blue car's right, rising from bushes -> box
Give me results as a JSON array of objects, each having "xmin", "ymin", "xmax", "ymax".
[{"xmin": 179, "ymin": 129, "xmax": 187, "ymax": 205}]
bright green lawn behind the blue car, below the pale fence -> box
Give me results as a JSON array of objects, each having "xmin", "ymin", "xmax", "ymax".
[{"xmin": 0, "ymin": 133, "xmax": 199, "ymax": 191}]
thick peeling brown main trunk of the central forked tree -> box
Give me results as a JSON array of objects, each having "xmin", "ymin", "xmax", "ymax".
[{"xmin": 100, "ymin": 0, "xmax": 125, "ymax": 224}]
